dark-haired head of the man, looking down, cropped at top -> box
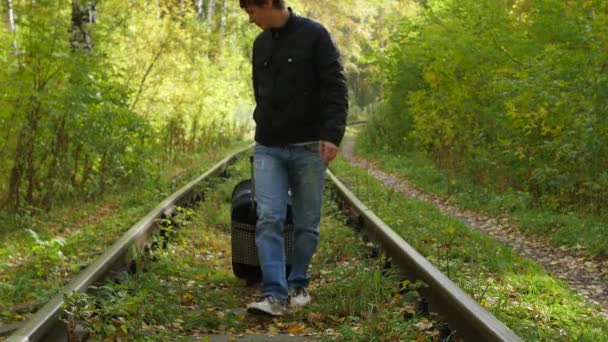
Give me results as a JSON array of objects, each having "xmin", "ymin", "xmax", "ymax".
[{"xmin": 239, "ymin": 0, "xmax": 289, "ymax": 30}]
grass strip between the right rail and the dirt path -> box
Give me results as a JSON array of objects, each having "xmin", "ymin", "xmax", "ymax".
[{"xmin": 332, "ymin": 156, "xmax": 608, "ymax": 341}]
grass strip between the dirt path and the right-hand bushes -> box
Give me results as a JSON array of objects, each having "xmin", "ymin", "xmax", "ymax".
[{"xmin": 357, "ymin": 132, "xmax": 608, "ymax": 258}]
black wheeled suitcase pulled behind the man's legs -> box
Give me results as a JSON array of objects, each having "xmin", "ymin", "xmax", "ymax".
[{"xmin": 230, "ymin": 157, "xmax": 293, "ymax": 283}]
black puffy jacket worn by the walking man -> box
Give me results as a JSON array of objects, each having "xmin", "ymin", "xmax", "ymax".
[{"xmin": 253, "ymin": 9, "xmax": 348, "ymax": 146}]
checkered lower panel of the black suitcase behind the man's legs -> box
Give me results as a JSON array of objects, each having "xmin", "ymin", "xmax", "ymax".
[{"xmin": 231, "ymin": 220, "xmax": 293, "ymax": 266}]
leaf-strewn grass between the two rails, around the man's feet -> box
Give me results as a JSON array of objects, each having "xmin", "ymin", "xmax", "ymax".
[{"xmin": 60, "ymin": 156, "xmax": 437, "ymax": 341}]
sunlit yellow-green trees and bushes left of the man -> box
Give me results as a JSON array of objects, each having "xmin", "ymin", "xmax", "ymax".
[{"xmin": 0, "ymin": 0, "xmax": 255, "ymax": 212}]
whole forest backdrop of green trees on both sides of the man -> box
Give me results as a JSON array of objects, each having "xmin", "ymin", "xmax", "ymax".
[{"xmin": 0, "ymin": 0, "xmax": 608, "ymax": 255}]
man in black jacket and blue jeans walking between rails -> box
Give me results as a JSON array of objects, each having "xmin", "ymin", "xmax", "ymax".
[{"xmin": 240, "ymin": 0, "xmax": 348, "ymax": 316}]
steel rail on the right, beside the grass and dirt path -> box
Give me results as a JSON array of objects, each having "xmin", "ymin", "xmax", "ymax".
[{"xmin": 327, "ymin": 170, "xmax": 522, "ymax": 342}]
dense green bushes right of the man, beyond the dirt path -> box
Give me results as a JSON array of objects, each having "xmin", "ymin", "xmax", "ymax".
[{"xmin": 364, "ymin": 0, "xmax": 608, "ymax": 214}]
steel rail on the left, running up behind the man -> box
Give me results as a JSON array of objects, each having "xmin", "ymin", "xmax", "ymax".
[{"xmin": 7, "ymin": 145, "xmax": 251, "ymax": 342}]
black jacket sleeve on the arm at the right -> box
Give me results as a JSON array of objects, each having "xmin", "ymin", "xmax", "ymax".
[{"xmin": 315, "ymin": 28, "xmax": 348, "ymax": 146}]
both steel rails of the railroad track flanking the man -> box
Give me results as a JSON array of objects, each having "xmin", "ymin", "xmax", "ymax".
[{"xmin": 2, "ymin": 148, "xmax": 521, "ymax": 342}]
